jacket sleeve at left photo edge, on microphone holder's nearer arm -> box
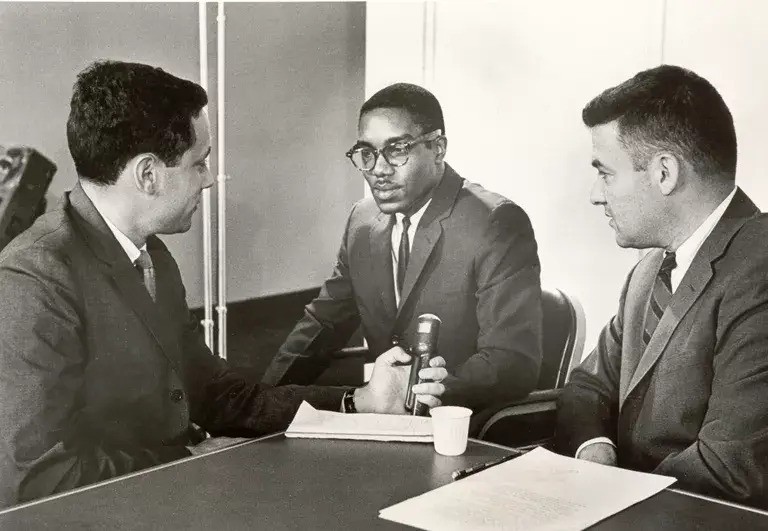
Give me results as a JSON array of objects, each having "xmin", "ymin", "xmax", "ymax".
[{"xmin": 0, "ymin": 254, "xmax": 189, "ymax": 506}]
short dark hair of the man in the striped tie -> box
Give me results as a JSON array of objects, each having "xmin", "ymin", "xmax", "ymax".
[{"xmin": 582, "ymin": 65, "xmax": 736, "ymax": 181}]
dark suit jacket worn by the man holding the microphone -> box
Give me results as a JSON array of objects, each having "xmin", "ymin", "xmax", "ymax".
[{"xmin": 0, "ymin": 185, "xmax": 343, "ymax": 506}]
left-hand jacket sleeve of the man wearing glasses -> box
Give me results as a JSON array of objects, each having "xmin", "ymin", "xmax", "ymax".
[{"xmin": 262, "ymin": 208, "xmax": 360, "ymax": 386}]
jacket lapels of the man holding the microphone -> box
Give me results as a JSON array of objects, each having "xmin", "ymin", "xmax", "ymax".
[{"xmin": 69, "ymin": 183, "xmax": 180, "ymax": 372}]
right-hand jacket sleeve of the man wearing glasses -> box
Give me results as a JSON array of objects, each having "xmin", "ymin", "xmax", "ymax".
[{"xmin": 442, "ymin": 202, "xmax": 542, "ymax": 408}]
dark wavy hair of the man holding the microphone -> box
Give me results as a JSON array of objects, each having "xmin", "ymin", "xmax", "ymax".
[{"xmin": 67, "ymin": 61, "xmax": 208, "ymax": 185}]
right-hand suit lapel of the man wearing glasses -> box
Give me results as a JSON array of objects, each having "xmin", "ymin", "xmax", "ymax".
[{"xmin": 397, "ymin": 164, "xmax": 463, "ymax": 318}]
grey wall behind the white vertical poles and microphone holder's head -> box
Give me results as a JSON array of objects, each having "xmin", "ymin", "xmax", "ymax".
[{"xmin": 0, "ymin": 2, "xmax": 365, "ymax": 306}]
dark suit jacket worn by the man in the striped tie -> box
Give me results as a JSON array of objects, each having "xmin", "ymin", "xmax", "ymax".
[{"xmin": 558, "ymin": 190, "xmax": 768, "ymax": 507}]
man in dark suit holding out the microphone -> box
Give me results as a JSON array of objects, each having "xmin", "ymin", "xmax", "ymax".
[{"xmin": 0, "ymin": 61, "xmax": 446, "ymax": 507}]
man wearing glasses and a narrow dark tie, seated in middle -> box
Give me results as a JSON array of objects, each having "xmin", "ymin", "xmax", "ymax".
[{"xmin": 264, "ymin": 83, "xmax": 541, "ymax": 409}]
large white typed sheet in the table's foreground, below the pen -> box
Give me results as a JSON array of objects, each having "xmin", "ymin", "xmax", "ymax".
[{"xmin": 379, "ymin": 448, "xmax": 675, "ymax": 531}]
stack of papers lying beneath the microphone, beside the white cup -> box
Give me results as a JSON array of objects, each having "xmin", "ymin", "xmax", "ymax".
[{"xmin": 285, "ymin": 402, "xmax": 432, "ymax": 442}]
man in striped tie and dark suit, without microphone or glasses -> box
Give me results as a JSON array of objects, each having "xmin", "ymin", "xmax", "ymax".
[{"xmin": 558, "ymin": 65, "xmax": 768, "ymax": 507}]
